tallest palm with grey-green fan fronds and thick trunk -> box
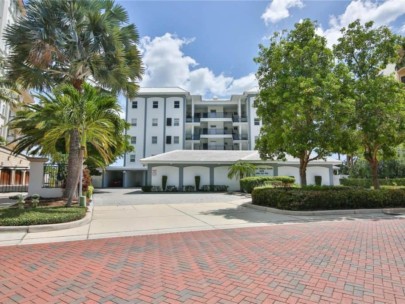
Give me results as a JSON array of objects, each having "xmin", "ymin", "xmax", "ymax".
[{"xmin": 5, "ymin": 0, "xmax": 143, "ymax": 202}]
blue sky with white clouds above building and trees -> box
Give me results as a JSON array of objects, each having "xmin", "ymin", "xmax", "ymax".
[{"xmin": 117, "ymin": 0, "xmax": 405, "ymax": 97}]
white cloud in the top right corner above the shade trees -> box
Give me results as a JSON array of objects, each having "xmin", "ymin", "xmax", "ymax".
[{"xmin": 318, "ymin": 0, "xmax": 405, "ymax": 46}]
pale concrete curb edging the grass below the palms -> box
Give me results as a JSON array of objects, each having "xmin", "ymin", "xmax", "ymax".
[{"xmin": 0, "ymin": 206, "xmax": 93, "ymax": 233}]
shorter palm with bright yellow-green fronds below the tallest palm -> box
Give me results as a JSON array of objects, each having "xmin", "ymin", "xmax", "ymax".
[{"xmin": 10, "ymin": 83, "xmax": 129, "ymax": 206}]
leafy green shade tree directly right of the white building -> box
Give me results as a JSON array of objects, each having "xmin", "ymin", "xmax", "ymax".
[{"xmin": 255, "ymin": 19, "xmax": 352, "ymax": 186}]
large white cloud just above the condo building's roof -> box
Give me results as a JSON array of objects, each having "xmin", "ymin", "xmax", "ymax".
[{"xmin": 140, "ymin": 33, "xmax": 257, "ymax": 96}]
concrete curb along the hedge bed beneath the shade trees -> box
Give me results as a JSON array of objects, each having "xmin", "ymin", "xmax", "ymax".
[{"xmin": 242, "ymin": 203, "xmax": 405, "ymax": 216}]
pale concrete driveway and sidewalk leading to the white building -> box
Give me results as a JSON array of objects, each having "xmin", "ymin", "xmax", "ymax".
[{"xmin": 0, "ymin": 190, "xmax": 395, "ymax": 246}]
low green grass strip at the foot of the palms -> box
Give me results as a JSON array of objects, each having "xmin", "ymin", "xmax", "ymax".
[{"xmin": 0, "ymin": 207, "xmax": 87, "ymax": 226}]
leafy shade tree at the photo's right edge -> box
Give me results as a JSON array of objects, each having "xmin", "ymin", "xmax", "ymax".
[{"xmin": 334, "ymin": 20, "xmax": 405, "ymax": 189}]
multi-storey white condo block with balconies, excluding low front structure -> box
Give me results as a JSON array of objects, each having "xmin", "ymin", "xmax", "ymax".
[{"xmin": 105, "ymin": 88, "xmax": 260, "ymax": 187}]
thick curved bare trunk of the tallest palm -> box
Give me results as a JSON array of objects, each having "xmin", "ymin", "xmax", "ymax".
[{"xmin": 64, "ymin": 130, "xmax": 81, "ymax": 207}]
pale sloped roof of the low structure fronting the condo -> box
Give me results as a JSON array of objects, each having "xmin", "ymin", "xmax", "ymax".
[{"xmin": 141, "ymin": 150, "xmax": 342, "ymax": 165}]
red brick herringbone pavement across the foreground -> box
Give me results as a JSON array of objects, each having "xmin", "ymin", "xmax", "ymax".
[{"xmin": 0, "ymin": 219, "xmax": 405, "ymax": 303}]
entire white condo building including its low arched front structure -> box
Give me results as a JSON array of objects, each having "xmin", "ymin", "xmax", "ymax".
[{"xmin": 100, "ymin": 88, "xmax": 340, "ymax": 190}]
